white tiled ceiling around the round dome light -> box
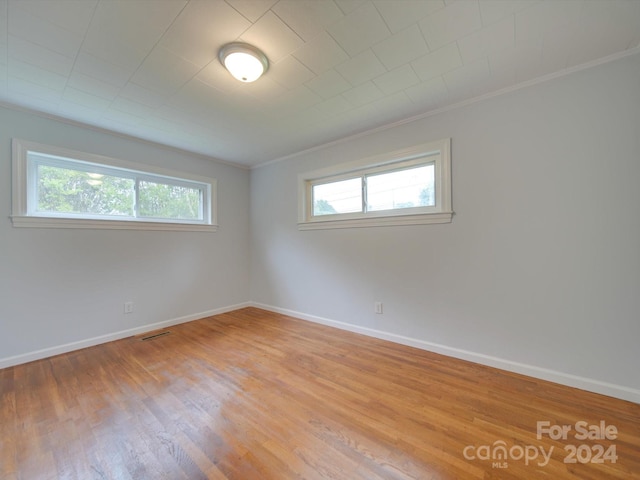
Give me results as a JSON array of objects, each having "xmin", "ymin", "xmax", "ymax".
[{"xmin": 0, "ymin": 0, "xmax": 640, "ymax": 166}]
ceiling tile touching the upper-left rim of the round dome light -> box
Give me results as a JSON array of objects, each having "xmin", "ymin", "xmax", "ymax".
[{"xmin": 160, "ymin": 0, "xmax": 251, "ymax": 66}]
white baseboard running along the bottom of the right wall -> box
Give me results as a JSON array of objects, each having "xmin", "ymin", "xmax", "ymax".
[{"xmin": 251, "ymin": 302, "xmax": 640, "ymax": 404}]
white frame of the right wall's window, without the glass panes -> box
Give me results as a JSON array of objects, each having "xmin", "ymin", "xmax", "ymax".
[{"xmin": 298, "ymin": 138, "xmax": 453, "ymax": 230}]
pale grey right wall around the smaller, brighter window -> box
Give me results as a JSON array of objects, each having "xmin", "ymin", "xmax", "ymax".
[{"xmin": 251, "ymin": 55, "xmax": 640, "ymax": 402}]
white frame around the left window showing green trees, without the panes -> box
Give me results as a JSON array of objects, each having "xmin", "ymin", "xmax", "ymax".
[{"xmin": 11, "ymin": 138, "xmax": 218, "ymax": 232}]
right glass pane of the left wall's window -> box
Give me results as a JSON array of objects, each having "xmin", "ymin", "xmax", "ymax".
[{"xmin": 138, "ymin": 180, "xmax": 203, "ymax": 220}]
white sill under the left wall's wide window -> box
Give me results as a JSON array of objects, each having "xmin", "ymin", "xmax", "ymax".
[{"xmin": 11, "ymin": 215, "xmax": 218, "ymax": 232}]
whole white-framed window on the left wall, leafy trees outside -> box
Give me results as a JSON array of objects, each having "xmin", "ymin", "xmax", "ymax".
[{"xmin": 12, "ymin": 139, "xmax": 216, "ymax": 231}]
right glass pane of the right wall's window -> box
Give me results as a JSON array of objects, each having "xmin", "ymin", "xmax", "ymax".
[{"xmin": 367, "ymin": 164, "xmax": 436, "ymax": 212}]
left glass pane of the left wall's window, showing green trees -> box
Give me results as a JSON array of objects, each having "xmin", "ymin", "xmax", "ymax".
[{"xmin": 36, "ymin": 165, "xmax": 134, "ymax": 216}]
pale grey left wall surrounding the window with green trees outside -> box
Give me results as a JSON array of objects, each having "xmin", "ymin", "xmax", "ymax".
[{"xmin": 0, "ymin": 108, "xmax": 249, "ymax": 367}]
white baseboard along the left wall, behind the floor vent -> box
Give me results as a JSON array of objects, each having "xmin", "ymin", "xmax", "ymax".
[{"xmin": 0, "ymin": 302, "xmax": 251, "ymax": 368}]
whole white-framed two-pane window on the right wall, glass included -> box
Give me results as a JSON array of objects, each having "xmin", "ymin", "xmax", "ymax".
[{"xmin": 298, "ymin": 139, "xmax": 453, "ymax": 230}]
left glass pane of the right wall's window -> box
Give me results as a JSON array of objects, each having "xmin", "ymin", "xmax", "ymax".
[{"xmin": 313, "ymin": 177, "xmax": 362, "ymax": 216}]
